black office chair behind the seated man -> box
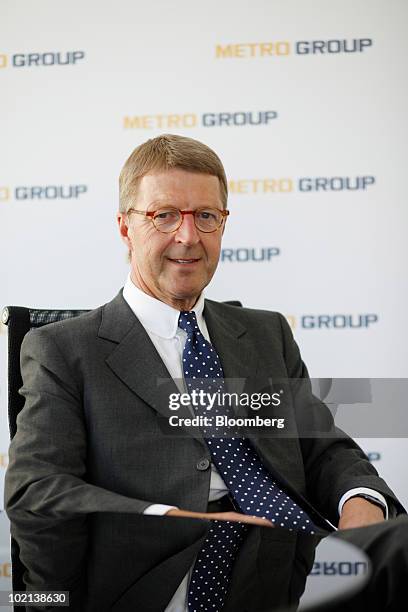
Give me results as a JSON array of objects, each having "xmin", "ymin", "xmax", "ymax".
[{"xmin": 1, "ymin": 301, "xmax": 242, "ymax": 600}]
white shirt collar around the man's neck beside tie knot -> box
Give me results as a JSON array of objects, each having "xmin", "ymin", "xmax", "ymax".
[{"xmin": 123, "ymin": 274, "xmax": 204, "ymax": 338}]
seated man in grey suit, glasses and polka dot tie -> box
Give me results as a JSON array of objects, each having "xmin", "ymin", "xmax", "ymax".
[{"xmin": 6, "ymin": 135, "xmax": 403, "ymax": 612}]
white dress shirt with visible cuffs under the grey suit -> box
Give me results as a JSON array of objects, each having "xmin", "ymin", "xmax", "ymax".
[{"xmin": 123, "ymin": 275, "xmax": 388, "ymax": 612}]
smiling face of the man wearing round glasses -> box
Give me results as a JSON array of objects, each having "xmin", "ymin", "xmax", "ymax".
[{"xmin": 118, "ymin": 168, "xmax": 223, "ymax": 310}]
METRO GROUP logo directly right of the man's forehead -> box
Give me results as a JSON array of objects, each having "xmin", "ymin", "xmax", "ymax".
[{"xmin": 228, "ymin": 175, "xmax": 376, "ymax": 195}]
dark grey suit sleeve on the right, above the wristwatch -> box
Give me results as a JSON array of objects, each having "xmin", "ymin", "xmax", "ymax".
[{"xmin": 280, "ymin": 315, "xmax": 405, "ymax": 525}]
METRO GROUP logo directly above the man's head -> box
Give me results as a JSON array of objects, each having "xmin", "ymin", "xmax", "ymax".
[{"xmin": 123, "ymin": 110, "xmax": 278, "ymax": 130}]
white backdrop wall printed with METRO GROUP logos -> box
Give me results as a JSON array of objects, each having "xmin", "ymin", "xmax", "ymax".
[{"xmin": 0, "ymin": 0, "xmax": 408, "ymax": 604}]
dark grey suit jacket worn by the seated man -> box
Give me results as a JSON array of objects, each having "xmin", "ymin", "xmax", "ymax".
[{"xmin": 5, "ymin": 292, "xmax": 401, "ymax": 612}]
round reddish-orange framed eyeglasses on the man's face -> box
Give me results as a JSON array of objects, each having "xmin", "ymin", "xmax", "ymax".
[{"xmin": 128, "ymin": 208, "xmax": 229, "ymax": 234}]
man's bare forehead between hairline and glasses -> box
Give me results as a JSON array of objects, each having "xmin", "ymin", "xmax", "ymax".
[{"xmin": 138, "ymin": 168, "xmax": 221, "ymax": 208}]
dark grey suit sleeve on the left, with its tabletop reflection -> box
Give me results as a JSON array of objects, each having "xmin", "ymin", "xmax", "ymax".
[{"xmin": 5, "ymin": 329, "xmax": 157, "ymax": 610}]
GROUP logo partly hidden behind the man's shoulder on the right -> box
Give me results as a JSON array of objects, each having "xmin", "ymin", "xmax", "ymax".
[{"xmin": 286, "ymin": 313, "xmax": 379, "ymax": 330}]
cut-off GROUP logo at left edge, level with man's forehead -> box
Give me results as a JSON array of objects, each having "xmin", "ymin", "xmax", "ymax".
[{"xmin": 0, "ymin": 185, "xmax": 88, "ymax": 202}]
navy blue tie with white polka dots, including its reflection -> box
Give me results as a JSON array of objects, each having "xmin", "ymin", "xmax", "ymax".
[{"xmin": 179, "ymin": 312, "xmax": 316, "ymax": 612}]
